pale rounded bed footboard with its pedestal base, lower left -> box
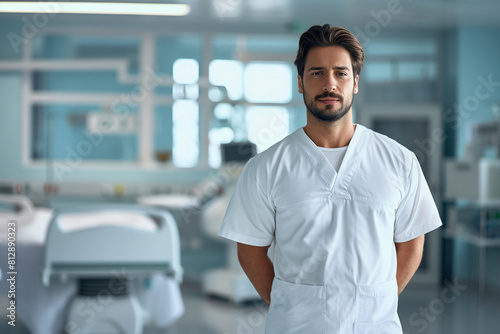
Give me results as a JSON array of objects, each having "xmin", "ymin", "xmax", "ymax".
[{"xmin": 43, "ymin": 205, "xmax": 183, "ymax": 334}]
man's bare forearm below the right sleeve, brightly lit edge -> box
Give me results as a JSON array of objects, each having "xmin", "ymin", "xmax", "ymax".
[{"xmin": 395, "ymin": 235, "xmax": 425, "ymax": 294}]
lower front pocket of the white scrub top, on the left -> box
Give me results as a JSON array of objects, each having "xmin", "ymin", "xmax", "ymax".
[{"xmin": 266, "ymin": 278, "xmax": 326, "ymax": 334}]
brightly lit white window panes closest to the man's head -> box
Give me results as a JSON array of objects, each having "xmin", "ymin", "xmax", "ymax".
[{"xmin": 209, "ymin": 59, "xmax": 292, "ymax": 168}]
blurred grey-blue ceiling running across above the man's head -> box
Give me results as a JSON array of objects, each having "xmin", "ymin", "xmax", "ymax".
[{"xmin": 0, "ymin": 0, "xmax": 500, "ymax": 33}]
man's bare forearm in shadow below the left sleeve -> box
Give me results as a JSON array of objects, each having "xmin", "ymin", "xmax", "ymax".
[{"xmin": 238, "ymin": 243, "xmax": 274, "ymax": 305}]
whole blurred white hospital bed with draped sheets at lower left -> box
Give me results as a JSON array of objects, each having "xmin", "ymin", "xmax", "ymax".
[{"xmin": 0, "ymin": 195, "xmax": 184, "ymax": 334}]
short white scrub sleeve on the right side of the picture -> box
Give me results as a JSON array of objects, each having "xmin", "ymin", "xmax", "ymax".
[{"xmin": 394, "ymin": 153, "xmax": 442, "ymax": 242}]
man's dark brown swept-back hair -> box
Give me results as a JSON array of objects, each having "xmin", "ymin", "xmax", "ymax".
[{"xmin": 294, "ymin": 24, "xmax": 365, "ymax": 77}]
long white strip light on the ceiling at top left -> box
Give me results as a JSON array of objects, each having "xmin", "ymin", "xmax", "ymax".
[{"xmin": 0, "ymin": 1, "xmax": 190, "ymax": 16}]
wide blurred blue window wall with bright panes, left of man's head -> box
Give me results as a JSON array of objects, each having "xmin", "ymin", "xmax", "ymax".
[{"xmin": 16, "ymin": 32, "xmax": 303, "ymax": 168}]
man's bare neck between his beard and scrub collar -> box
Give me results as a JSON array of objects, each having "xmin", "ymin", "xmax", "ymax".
[{"xmin": 304, "ymin": 115, "xmax": 356, "ymax": 148}]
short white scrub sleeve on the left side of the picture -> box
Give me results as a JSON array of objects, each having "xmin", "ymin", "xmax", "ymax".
[{"xmin": 219, "ymin": 159, "xmax": 275, "ymax": 247}]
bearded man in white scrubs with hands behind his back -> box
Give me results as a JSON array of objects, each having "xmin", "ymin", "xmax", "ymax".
[{"xmin": 220, "ymin": 25, "xmax": 441, "ymax": 334}]
